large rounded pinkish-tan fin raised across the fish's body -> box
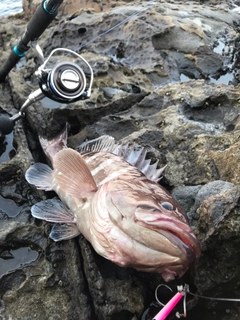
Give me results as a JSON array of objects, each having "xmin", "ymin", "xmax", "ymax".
[{"xmin": 53, "ymin": 148, "xmax": 97, "ymax": 198}]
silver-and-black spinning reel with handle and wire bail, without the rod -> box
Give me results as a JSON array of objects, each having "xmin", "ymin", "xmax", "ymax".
[{"xmin": 0, "ymin": 45, "xmax": 93, "ymax": 135}]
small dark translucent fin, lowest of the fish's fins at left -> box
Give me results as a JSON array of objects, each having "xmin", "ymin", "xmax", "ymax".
[{"xmin": 50, "ymin": 224, "xmax": 80, "ymax": 241}]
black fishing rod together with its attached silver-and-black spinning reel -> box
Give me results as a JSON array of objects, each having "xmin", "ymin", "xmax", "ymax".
[{"xmin": 0, "ymin": 0, "xmax": 93, "ymax": 138}]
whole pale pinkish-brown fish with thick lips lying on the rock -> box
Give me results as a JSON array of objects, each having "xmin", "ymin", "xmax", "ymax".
[{"xmin": 25, "ymin": 129, "xmax": 201, "ymax": 282}]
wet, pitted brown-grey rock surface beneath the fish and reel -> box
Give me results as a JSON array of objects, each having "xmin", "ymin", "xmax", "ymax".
[{"xmin": 0, "ymin": 0, "xmax": 240, "ymax": 320}]
